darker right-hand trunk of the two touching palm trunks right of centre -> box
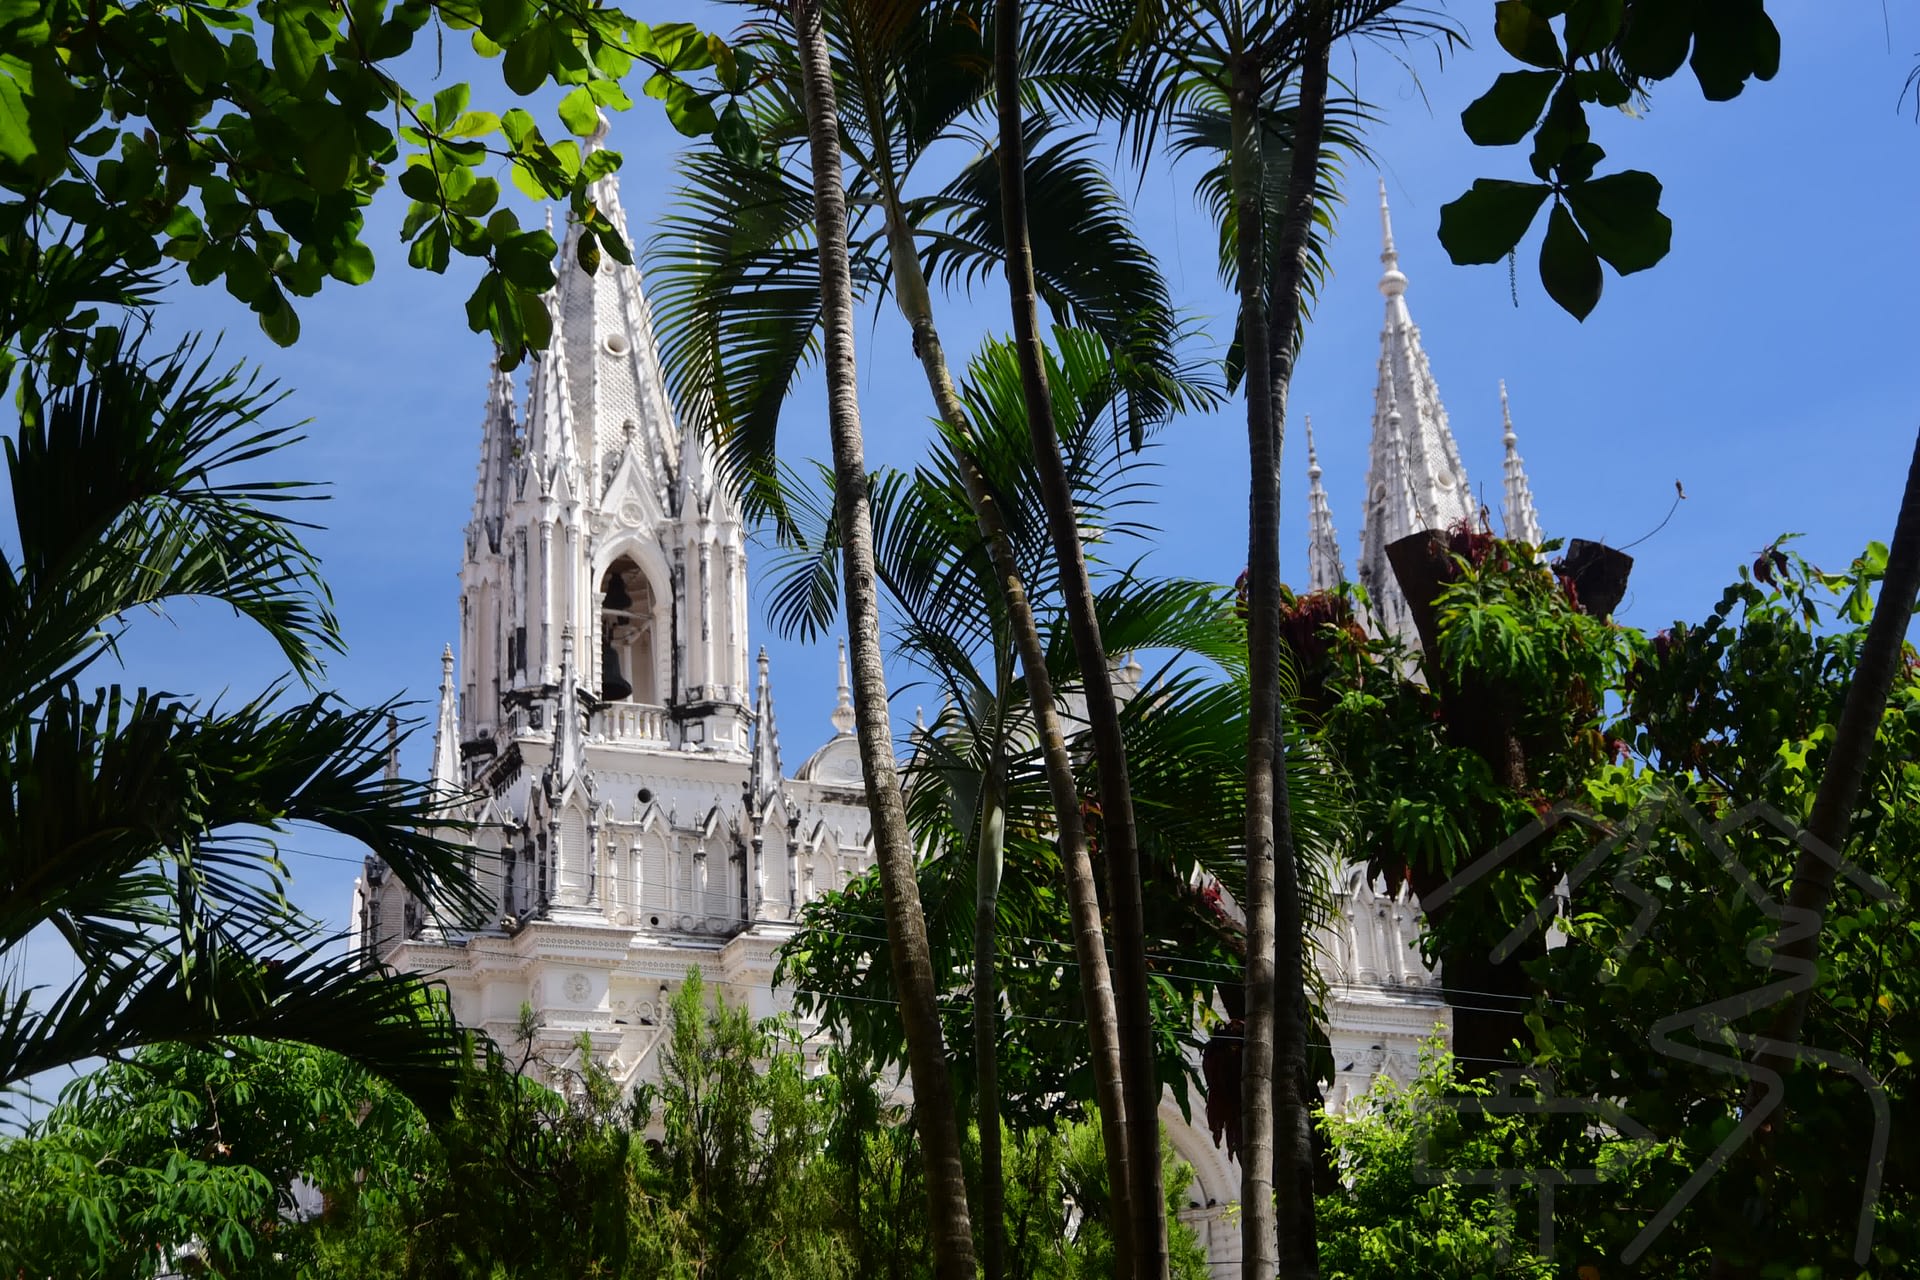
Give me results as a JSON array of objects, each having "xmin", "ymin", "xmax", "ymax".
[{"xmin": 1248, "ymin": 23, "xmax": 1332, "ymax": 1280}]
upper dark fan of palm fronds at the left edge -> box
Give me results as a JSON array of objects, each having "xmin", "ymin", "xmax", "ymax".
[{"xmin": 0, "ymin": 336, "xmax": 340, "ymax": 714}]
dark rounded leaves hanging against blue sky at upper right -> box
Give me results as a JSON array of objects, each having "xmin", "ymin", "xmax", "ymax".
[{"xmin": 1440, "ymin": 0, "xmax": 1780, "ymax": 320}]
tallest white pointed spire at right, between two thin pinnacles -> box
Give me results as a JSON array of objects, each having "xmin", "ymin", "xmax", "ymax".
[{"xmin": 1359, "ymin": 180, "xmax": 1475, "ymax": 637}]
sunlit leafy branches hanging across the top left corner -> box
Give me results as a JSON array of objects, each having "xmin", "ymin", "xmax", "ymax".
[{"xmin": 0, "ymin": 0, "xmax": 755, "ymax": 376}]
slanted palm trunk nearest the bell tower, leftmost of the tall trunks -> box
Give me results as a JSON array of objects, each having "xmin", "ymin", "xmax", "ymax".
[{"xmin": 791, "ymin": 0, "xmax": 973, "ymax": 1280}]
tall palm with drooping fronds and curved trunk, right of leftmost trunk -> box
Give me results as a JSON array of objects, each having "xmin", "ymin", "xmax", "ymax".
[{"xmin": 655, "ymin": 0, "xmax": 1190, "ymax": 1265}]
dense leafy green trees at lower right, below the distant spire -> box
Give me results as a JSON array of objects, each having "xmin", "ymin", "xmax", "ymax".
[{"xmin": 1294, "ymin": 539, "xmax": 1920, "ymax": 1278}]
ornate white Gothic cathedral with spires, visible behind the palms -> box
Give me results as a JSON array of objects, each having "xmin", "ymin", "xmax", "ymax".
[{"xmin": 351, "ymin": 163, "xmax": 1540, "ymax": 1274}]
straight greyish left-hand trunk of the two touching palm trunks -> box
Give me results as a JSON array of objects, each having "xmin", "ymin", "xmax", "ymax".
[{"xmin": 1229, "ymin": 54, "xmax": 1284, "ymax": 1280}]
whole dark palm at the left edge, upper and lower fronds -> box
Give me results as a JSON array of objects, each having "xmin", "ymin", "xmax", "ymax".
[{"xmin": 0, "ymin": 332, "xmax": 478, "ymax": 1105}]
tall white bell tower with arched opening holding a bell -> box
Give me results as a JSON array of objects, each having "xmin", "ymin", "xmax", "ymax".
[{"xmin": 457, "ymin": 126, "xmax": 753, "ymax": 760}]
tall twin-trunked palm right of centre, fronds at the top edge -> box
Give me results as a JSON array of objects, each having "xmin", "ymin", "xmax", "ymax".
[{"xmin": 998, "ymin": 0, "xmax": 1430, "ymax": 1278}]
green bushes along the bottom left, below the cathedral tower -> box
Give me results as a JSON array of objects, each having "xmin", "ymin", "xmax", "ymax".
[{"xmin": 0, "ymin": 969, "xmax": 1206, "ymax": 1280}]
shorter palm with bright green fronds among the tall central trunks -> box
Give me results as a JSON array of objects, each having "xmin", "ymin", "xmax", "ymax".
[{"xmin": 770, "ymin": 330, "xmax": 1334, "ymax": 1274}]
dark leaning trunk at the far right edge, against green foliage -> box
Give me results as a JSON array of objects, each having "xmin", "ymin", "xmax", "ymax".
[{"xmin": 1713, "ymin": 426, "xmax": 1920, "ymax": 1280}]
